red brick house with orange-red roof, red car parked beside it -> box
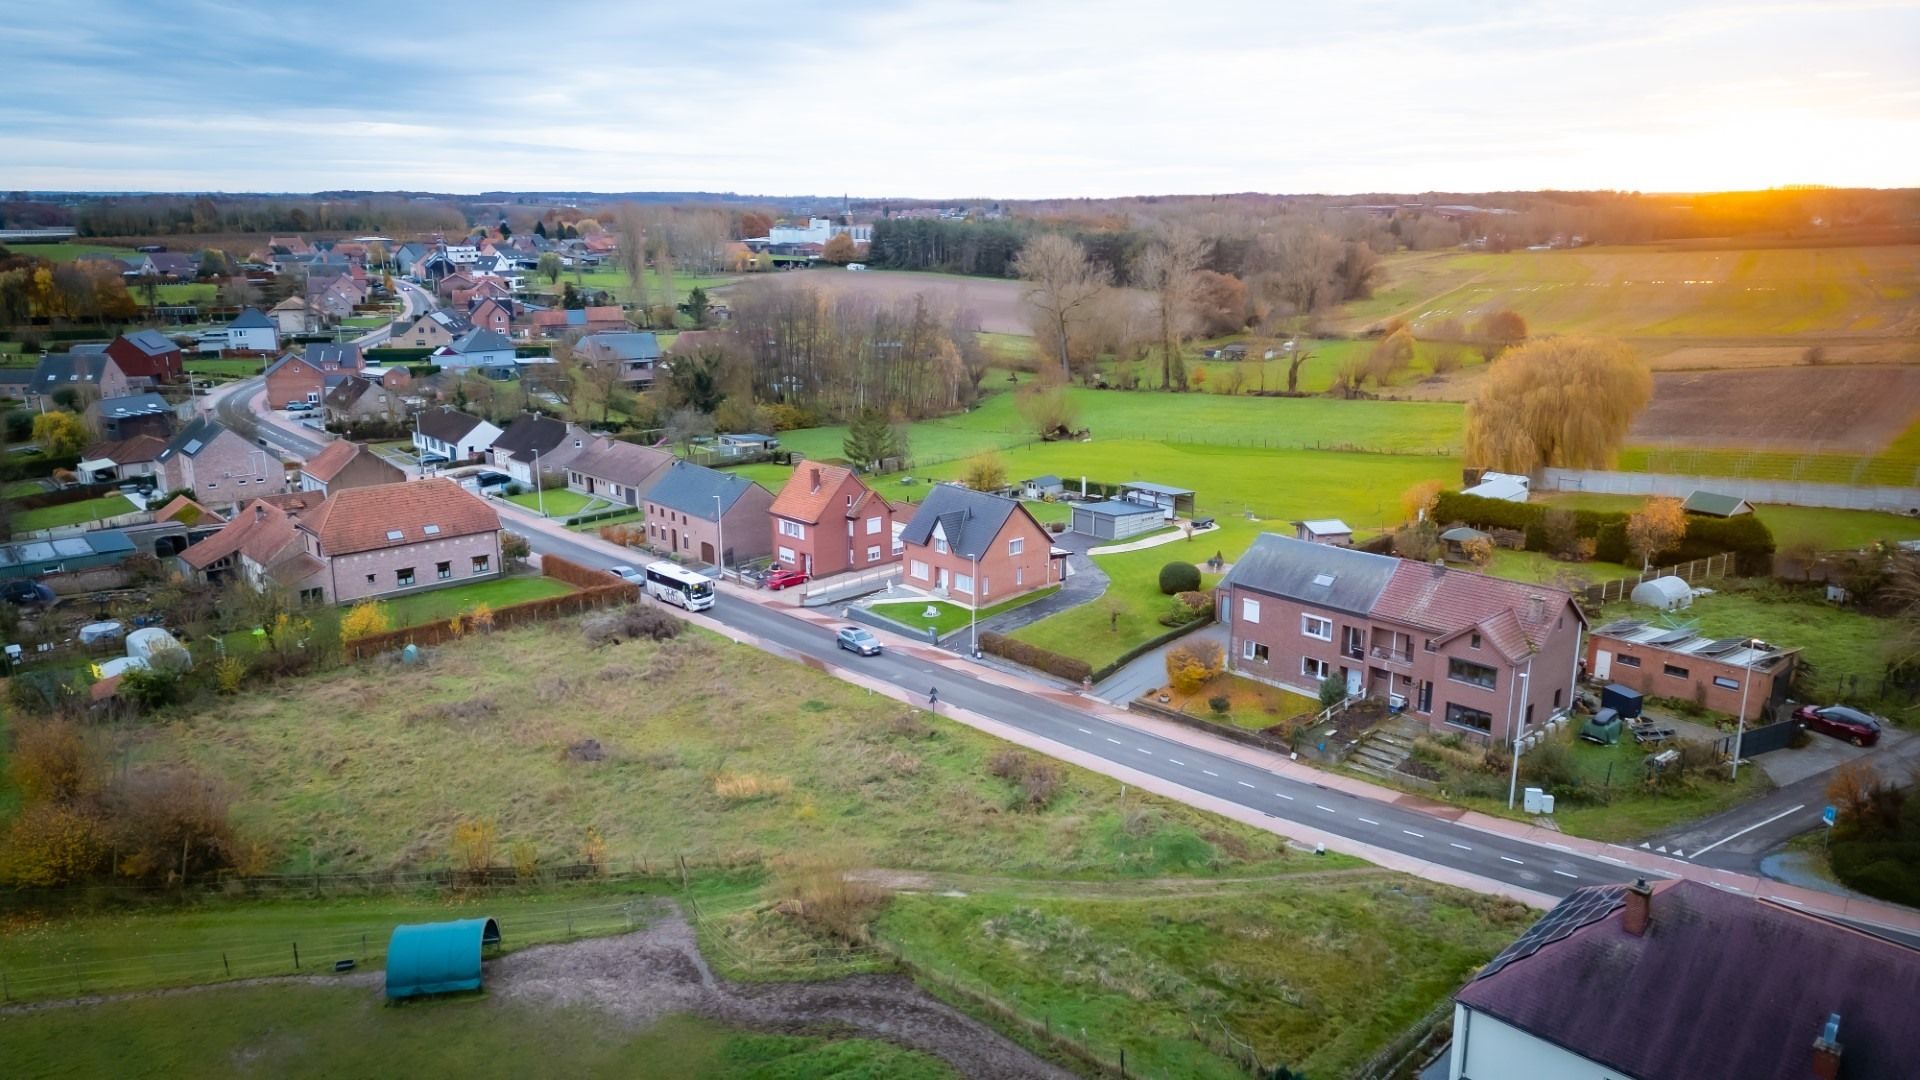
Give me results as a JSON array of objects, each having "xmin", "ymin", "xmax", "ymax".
[{"xmin": 768, "ymin": 461, "xmax": 904, "ymax": 577}]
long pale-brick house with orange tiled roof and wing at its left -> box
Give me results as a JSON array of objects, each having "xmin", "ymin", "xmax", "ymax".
[{"xmin": 180, "ymin": 479, "xmax": 501, "ymax": 603}]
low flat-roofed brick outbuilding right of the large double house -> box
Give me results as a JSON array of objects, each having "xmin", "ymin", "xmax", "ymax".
[{"xmin": 1586, "ymin": 619, "xmax": 1799, "ymax": 721}]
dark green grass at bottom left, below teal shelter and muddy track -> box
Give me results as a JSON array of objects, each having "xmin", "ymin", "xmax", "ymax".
[{"xmin": 0, "ymin": 986, "xmax": 952, "ymax": 1080}]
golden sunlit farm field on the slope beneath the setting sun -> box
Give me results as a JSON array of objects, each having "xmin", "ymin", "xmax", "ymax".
[{"xmin": 1342, "ymin": 244, "xmax": 1920, "ymax": 340}]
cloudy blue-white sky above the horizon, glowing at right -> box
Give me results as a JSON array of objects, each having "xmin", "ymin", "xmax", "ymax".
[{"xmin": 0, "ymin": 0, "xmax": 1920, "ymax": 198}]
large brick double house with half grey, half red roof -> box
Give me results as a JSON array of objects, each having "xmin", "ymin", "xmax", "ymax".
[{"xmin": 1215, "ymin": 532, "xmax": 1586, "ymax": 742}]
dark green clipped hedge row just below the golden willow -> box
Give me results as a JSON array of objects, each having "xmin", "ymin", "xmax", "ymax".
[{"xmin": 1434, "ymin": 492, "xmax": 1774, "ymax": 575}]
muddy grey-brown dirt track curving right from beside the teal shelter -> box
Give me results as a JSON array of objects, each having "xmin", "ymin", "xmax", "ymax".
[{"xmin": 486, "ymin": 899, "xmax": 1073, "ymax": 1080}]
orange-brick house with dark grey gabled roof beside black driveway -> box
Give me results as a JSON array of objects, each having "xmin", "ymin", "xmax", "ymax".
[{"xmin": 900, "ymin": 484, "xmax": 1068, "ymax": 607}]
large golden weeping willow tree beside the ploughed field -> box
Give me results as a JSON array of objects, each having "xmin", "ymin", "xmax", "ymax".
[{"xmin": 1467, "ymin": 338, "xmax": 1653, "ymax": 473}]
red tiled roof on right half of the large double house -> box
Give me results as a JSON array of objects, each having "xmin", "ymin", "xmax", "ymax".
[{"xmin": 1373, "ymin": 561, "xmax": 1578, "ymax": 659}]
